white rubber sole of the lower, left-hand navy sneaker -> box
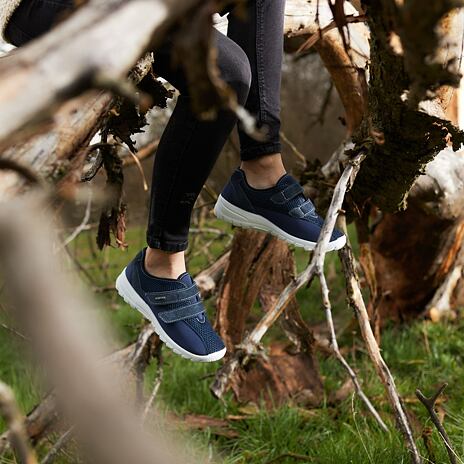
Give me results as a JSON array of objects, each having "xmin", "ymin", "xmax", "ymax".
[{"xmin": 116, "ymin": 269, "xmax": 226, "ymax": 362}]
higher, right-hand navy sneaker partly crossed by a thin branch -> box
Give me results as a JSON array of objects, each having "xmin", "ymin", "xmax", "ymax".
[{"xmin": 214, "ymin": 169, "xmax": 346, "ymax": 251}]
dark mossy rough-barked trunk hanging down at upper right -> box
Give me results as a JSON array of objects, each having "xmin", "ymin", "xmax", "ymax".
[{"xmin": 352, "ymin": 0, "xmax": 464, "ymax": 212}]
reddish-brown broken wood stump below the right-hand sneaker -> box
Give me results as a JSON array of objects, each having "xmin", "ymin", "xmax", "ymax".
[{"xmin": 216, "ymin": 230, "xmax": 323, "ymax": 407}]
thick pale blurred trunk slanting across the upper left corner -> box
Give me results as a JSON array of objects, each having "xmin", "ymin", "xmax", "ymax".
[{"xmin": 0, "ymin": 0, "xmax": 200, "ymax": 149}]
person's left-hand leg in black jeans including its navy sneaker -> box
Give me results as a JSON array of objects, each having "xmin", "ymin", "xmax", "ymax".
[{"xmin": 116, "ymin": 32, "xmax": 251, "ymax": 362}]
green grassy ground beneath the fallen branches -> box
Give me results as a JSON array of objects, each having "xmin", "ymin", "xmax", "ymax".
[{"xmin": 0, "ymin": 221, "xmax": 464, "ymax": 464}]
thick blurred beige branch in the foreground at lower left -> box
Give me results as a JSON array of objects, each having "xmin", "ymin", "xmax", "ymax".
[{"xmin": 0, "ymin": 195, "xmax": 201, "ymax": 464}]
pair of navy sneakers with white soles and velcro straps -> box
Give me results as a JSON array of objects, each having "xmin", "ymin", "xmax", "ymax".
[{"xmin": 116, "ymin": 169, "xmax": 346, "ymax": 362}]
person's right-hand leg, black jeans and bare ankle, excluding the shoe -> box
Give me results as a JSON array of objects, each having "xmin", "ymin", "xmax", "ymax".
[{"xmin": 227, "ymin": 0, "xmax": 286, "ymax": 188}]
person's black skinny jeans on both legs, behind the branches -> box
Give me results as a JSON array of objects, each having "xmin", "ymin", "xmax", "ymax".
[{"xmin": 6, "ymin": 0, "xmax": 285, "ymax": 252}]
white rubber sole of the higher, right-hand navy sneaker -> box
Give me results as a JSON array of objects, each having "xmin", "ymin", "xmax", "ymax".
[{"xmin": 214, "ymin": 195, "xmax": 346, "ymax": 251}]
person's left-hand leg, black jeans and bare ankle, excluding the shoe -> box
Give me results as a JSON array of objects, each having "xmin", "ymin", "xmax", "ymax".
[{"xmin": 145, "ymin": 31, "xmax": 251, "ymax": 278}]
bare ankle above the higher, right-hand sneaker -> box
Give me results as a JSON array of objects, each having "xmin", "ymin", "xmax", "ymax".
[{"xmin": 240, "ymin": 153, "xmax": 286, "ymax": 189}]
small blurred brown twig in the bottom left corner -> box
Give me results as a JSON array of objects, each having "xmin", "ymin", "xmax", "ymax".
[{"xmin": 0, "ymin": 382, "xmax": 37, "ymax": 464}]
